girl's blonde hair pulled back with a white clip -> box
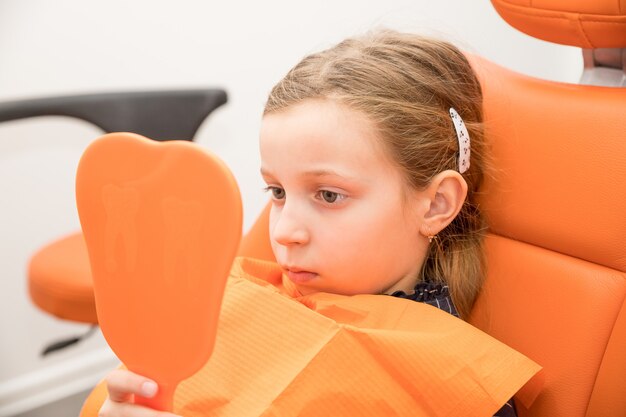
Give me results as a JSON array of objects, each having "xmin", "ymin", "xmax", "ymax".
[{"xmin": 264, "ymin": 31, "xmax": 486, "ymax": 318}]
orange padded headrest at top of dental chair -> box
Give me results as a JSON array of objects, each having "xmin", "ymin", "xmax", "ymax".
[{"xmin": 491, "ymin": 0, "xmax": 626, "ymax": 48}]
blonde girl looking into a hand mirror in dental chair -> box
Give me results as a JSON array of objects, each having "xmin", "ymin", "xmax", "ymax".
[{"xmin": 100, "ymin": 31, "xmax": 528, "ymax": 417}]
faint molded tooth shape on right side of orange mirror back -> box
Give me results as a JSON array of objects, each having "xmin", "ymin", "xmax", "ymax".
[{"xmin": 161, "ymin": 197, "xmax": 206, "ymax": 288}]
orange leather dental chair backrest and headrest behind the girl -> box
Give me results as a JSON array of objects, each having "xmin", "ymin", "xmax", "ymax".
[{"xmin": 240, "ymin": 0, "xmax": 626, "ymax": 417}]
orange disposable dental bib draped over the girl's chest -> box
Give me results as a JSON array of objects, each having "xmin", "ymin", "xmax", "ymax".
[{"xmin": 82, "ymin": 258, "xmax": 540, "ymax": 417}]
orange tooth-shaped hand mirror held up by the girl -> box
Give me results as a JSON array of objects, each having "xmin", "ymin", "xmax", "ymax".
[{"xmin": 76, "ymin": 133, "xmax": 242, "ymax": 411}]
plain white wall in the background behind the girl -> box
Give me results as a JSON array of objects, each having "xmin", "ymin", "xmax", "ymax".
[{"xmin": 0, "ymin": 0, "xmax": 582, "ymax": 416}]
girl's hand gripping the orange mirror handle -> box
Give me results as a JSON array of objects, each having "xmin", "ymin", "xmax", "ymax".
[{"xmin": 98, "ymin": 369, "xmax": 179, "ymax": 417}]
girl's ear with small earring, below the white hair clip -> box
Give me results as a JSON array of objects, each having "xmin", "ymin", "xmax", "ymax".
[{"xmin": 420, "ymin": 170, "xmax": 467, "ymax": 236}]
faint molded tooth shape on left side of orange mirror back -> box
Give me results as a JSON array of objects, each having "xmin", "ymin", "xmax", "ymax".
[{"xmin": 102, "ymin": 184, "xmax": 139, "ymax": 273}]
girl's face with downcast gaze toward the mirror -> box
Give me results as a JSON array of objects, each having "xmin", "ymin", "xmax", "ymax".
[{"xmin": 260, "ymin": 100, "xmax": 428, "ymax": 295}]
